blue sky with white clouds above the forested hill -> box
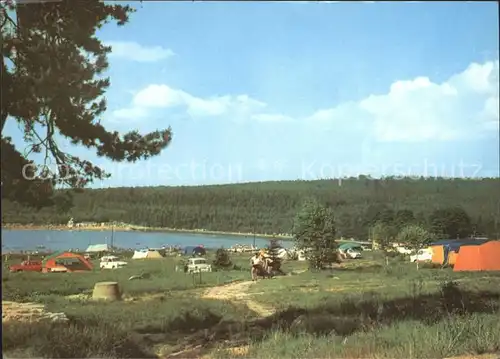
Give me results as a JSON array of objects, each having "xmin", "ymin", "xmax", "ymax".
[{"xmin": 4, "ymin": 1, "xmax": 500, "ymax": 188}]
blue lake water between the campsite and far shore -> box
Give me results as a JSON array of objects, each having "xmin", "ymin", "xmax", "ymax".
[{"xmin": 2, "ymin": 229, "xmax": 293, "ymax": 253}]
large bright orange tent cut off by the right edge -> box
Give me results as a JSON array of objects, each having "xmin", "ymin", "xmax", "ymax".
[{"xmin": 453, "ymin": 241, "xmax": 500, "ymax": 272}]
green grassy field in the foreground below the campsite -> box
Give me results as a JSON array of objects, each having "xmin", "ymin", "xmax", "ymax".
[{"xmin": 2, "ymin": 253, "xmax": 500, "ymax": 358}]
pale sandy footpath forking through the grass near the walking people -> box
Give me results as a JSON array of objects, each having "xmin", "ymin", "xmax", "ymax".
[{"xmin": 202, "ymin": 280, "xmax": 275, "ymax": 317}]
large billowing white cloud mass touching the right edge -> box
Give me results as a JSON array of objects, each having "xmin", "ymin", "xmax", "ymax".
[{"xmin": 308, "ymin": 61, "xmax": 499, "ymax": 142}]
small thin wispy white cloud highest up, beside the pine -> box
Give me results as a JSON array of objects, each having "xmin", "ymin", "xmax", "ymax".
[{"xmin": 106, "ymin": 41, "xmax": 175, "ymax": 62}]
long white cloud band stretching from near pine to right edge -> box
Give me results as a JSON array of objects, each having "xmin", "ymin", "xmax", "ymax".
[{"xmin": 110, "ymin": 61, "xmax": 499, "ymax": 142}]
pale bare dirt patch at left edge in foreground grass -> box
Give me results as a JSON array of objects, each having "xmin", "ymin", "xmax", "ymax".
[{"xmin": 2, "ymin": 301, "xmax": 68, "ymax": 323}]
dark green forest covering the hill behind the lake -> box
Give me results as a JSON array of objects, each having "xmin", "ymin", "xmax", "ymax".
[{"xmin": 2, "ymin": 176, "xmax": 500, "ymax": 238}]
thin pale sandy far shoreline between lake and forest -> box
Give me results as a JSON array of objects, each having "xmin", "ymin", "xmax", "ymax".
[{"xmin": 2, "ymin": 223, "xmax": 293, "ymax": 240}]
